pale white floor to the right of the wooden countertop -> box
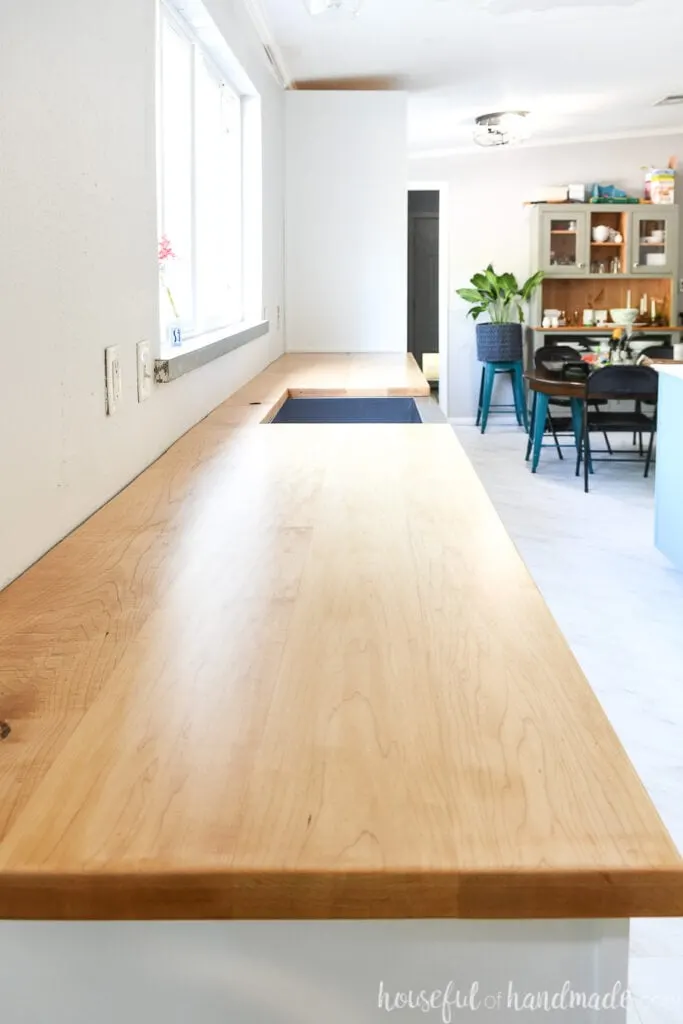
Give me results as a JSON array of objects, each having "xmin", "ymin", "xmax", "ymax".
[{"xmin": 454, "ymin": 418, "xmax": 683, "ymax": 1024}]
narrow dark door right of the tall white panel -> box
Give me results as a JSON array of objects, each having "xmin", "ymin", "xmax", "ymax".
[{"xmin": 408, "ymin": 191, "xmax": 439, "ymax": 369}]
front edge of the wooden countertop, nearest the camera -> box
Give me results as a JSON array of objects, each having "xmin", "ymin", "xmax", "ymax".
[{"xmin": 0, "ymin": 861, "xmax": 683, "ymax": 921}]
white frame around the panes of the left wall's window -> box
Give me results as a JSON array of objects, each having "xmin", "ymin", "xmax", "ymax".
[{"xmin": 156, "ymin": 0, "xmax": 246, "ymax": 349}]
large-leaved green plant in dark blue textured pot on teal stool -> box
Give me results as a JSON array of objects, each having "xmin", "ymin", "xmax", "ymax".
[{"xmin": 458, "ymin": 264, "xmax": 544, "ymax": 362}]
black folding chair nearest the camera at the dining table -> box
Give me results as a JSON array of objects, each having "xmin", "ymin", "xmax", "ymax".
[{"xmin": 577, "ymin": 366, "xmax": 658, "ymax": 494}]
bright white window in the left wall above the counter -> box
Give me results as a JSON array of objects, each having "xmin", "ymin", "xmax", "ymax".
[{"xmin": 159, "ymin": 5, "xmax": 244, "ymax": 338}]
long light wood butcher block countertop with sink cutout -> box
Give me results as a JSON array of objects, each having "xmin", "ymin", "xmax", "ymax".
[{"xmin": 0, "ymin": 356, "xmax": 683, "ymax": 919}]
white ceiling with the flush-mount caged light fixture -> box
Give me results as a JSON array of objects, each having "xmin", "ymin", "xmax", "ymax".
[{"xmin": 253, "ymin": 0, "xmax": 683, "ymax": 156}]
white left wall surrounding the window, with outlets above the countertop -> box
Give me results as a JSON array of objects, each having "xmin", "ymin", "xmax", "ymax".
[{"xmin": 0, "ymin": 0, "xmax": 284, "ymax": 586}]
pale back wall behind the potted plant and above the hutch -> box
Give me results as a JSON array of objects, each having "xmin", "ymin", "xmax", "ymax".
[{"xmin": 410, "ymin": 135, "xmax": 683, "ymax": 419}]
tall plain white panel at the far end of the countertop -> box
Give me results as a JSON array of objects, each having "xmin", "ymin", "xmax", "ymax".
[{"xmin": 286, "ymin": 91, "xmax": 408, "ymax": 352}]
